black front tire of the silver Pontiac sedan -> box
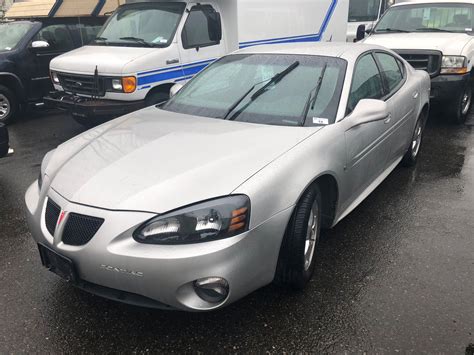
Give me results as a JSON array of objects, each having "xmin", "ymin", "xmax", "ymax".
[{"xmin": 275, "ymin": 184, "xmax": 322, "ymax": 290}]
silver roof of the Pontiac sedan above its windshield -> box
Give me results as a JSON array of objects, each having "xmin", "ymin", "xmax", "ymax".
[{"xmin": 234, "ymin": 42, "xmax": 390, "ymax": 59}]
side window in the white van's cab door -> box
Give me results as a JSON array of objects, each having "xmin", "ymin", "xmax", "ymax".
[{"xmin": 182, "ymin": 5, "xmax": 222, "ymax": 49}]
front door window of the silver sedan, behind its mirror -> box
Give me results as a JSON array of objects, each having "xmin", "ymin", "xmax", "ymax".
[{"xmin": 347, "ymin": 54, "xmax": 383, "ymax": 112}]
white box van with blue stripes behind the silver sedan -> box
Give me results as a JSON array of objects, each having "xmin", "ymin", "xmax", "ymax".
[{"xmin": 45, "ymin": 0, "xmax": 349, "ymax": 124}]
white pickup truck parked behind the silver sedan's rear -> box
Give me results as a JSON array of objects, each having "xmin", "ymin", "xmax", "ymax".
[{"xmin": 363, "ymin": 0, "xmax": 474, "ymax": 123}]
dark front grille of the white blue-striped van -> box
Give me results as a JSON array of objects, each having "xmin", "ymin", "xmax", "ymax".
[{"xmin": 58, "ymin": 73, "xmax": 105, "ymax": 96}]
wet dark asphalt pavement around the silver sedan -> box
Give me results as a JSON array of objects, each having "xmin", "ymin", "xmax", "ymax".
[{"xmin": 0, "ymin": 113, "xmax": 474, "ymax": 354}]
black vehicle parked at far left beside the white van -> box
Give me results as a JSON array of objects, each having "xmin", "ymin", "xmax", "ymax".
[{"xmin": 0, "ymin": 17, "xmax": 105, "ymax": 123}]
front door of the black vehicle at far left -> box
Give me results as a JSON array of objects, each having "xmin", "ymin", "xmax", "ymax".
[{"xmin": 30, "ymin": 24, "xmax": 75, "ymax": 99}]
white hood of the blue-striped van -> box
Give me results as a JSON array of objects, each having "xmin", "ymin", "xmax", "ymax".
[{"xmin": 50, "ymin": 46, "xmax": 156, "ymax": 75}]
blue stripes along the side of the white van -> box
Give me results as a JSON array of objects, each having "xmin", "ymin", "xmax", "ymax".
[{"xmin": 138, "ymin": 0, "xmax": 338, "ymax": 89}]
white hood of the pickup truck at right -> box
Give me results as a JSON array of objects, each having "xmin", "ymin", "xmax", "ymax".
[{"xmin": 363, "ymin": 32, "xmax": 472, "ymax": 55}]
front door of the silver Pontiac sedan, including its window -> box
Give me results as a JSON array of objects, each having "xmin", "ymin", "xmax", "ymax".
[{"xmin": 345, "ymin": 53, "xmax": 390, "ymax": 196}]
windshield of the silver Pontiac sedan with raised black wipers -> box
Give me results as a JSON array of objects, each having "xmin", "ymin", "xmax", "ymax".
[{"xmin": 162, "ymin": 54, "xmax": 347, "ymax": 126}]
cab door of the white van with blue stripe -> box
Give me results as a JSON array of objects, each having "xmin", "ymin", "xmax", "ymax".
[{"xmin": 179, "ymin": 3, "xmax": 226, "ymax": 79}]
